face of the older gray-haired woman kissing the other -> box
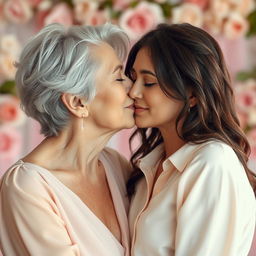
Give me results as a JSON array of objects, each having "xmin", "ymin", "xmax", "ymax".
[{"xmin": 89, "ymin": 43, "xmax": 134, "ymax": 130}]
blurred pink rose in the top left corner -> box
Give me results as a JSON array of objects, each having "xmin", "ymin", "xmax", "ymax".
[{"xmin": 3, "ymin": 0, "xmax": 33, "ymax": 23}]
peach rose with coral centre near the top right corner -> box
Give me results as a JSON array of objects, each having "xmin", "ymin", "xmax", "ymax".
[{"xmin": 223, "ymin": 12, "xmax": 249, "ymax": 39}]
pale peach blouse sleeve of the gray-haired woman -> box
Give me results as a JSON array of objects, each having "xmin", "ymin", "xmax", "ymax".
[{"xmin": 0, "ymin": 166, "xmax": 80, "ymax": 256}]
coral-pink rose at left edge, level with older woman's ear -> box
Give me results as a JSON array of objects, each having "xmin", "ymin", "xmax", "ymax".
[{"xmin": 0, "ymin": 95, "xmax": 25, "ymax": 125}]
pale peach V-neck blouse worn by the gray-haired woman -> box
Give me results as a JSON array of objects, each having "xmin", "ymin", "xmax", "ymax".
[{"xmin": 0, "ymin": 149, "xmax": 129, "ymax": 256}]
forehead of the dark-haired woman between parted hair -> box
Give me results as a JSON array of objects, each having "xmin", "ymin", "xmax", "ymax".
[{"xmin": 133, "ymin": 47, "xmax": 154, "ymax": 71}]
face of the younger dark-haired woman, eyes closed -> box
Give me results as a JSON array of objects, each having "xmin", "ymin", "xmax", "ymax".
[{"xmin": 129, "ymin": 48, "xmax": 184, "ymax": 129}]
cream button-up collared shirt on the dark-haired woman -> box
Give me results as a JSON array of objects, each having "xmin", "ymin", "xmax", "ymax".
[{"xmin": 129, "ymin": 141, "xmax": 256, "ymax": 256}]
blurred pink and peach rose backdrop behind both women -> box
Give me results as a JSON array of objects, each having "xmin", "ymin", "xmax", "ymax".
[{"xmin": 0, "ymin": 0, "xmax": 256, "ymax": 176}]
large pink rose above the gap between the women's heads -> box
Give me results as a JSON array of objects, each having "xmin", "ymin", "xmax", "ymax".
[{"xmin": 119, "ymin": 2, "xmax": 164, "ymax": 40}]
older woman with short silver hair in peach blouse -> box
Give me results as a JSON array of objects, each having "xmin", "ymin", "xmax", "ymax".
[{"xmin": 0, "ymin": 24, "xmax": 134, "ymax": 256}]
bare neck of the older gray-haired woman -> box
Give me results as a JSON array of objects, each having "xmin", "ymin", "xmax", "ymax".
[{"xmin": 24, "ymin": 120, "xmax": 114, "ymax": 174}]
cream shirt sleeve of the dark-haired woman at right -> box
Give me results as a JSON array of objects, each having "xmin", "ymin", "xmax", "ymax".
[{"xmin": 175, "ymin": 145, "xmax": 255, "ymax": 256}]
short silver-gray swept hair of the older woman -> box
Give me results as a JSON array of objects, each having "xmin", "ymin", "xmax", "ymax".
[{"xmin": 15, "ymin": 23, "xmax": 129, "ymax": 136}]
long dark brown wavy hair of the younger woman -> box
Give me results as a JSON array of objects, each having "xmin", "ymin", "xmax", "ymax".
[{"xmin": 125, "ymin": 24, "xmax": 256, "ymax": 195}]
